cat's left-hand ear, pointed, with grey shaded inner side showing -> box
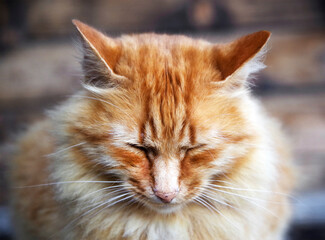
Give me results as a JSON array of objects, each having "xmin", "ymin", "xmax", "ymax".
[{"xmin": 72, "ymin": 19, "xmax": 127, "ymax": 90}]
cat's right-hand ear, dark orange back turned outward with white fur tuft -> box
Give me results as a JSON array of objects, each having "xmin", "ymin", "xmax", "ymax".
[{"xmin": 213, "ymin": 31, "xmax": 271, "ymax": 82}]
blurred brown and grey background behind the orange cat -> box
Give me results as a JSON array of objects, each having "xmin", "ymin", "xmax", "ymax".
[{"xmin": 0, "ymin": 0, "xmax": 325, "ymax": 240}]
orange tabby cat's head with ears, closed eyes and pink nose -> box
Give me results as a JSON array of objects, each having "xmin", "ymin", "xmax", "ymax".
[{"xmin": 55, "ymin": 20, "xmax": 270, "ymax": 212}]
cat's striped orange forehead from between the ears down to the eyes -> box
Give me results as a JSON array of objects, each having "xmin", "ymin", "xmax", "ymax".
[{"xmin": 109, "ymin": 34, "xmax": 218, "ymax": 146}]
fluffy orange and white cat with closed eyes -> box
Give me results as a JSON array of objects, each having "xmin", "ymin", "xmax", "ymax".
[{"xmin": 11, "ymin": 20, "xmax": 294, "ymax": 240}]
